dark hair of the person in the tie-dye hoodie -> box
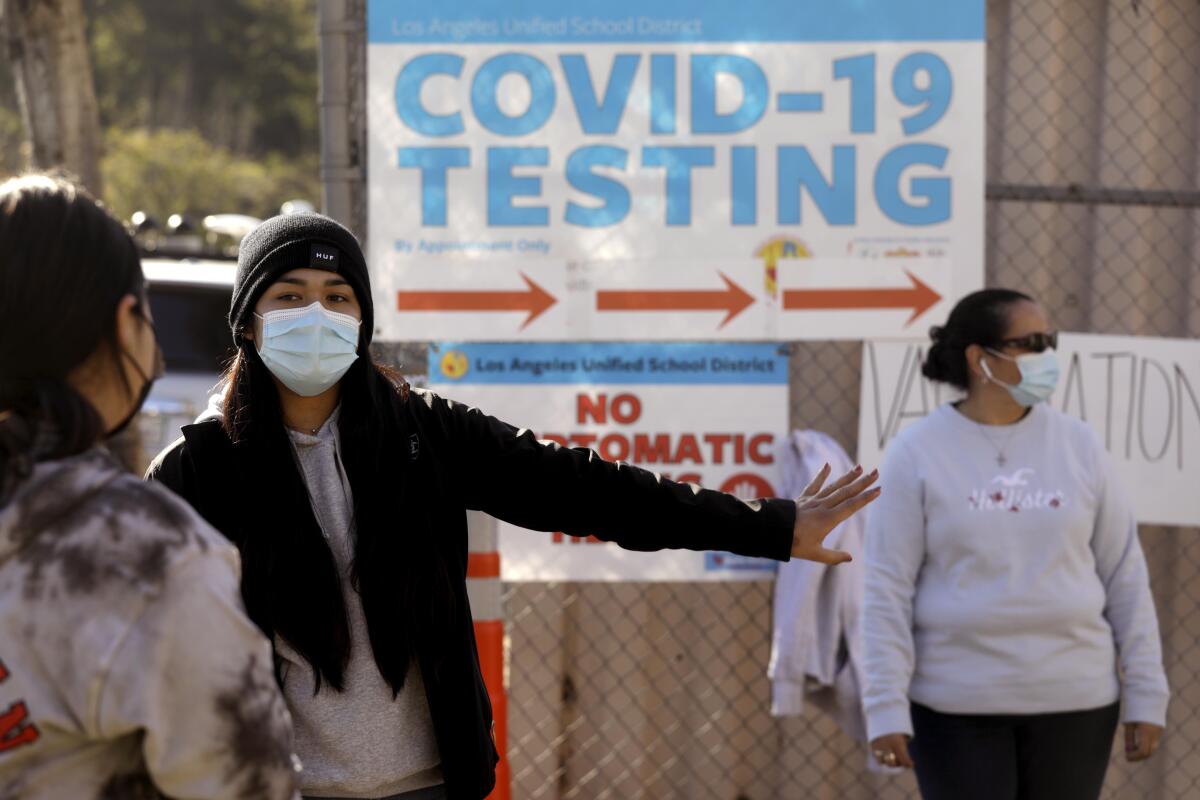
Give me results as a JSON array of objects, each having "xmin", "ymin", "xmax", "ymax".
[{"xmin": 0, "ymin": 175, "xmax": 145, "ymax": 498}]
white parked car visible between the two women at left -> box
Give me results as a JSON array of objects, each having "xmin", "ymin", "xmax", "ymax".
[{"xmin": 134, "ymin": 258, "xmax": 236, "ymax": 471}]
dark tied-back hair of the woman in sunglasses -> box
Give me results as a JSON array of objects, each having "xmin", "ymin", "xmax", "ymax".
[{"xmin": 922, "ymin": 289, "xmax": 1033, "ymax": 390}]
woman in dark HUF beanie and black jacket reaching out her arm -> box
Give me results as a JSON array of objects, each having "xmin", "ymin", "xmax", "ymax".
[{"xmin": 149, "ymin": 215, "xmax": 878, "ymax": 800}]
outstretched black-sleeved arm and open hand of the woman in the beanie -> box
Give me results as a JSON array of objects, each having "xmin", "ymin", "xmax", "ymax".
[{"xmin": 413, "ymin": 391, "xmax": 874, "ymax": 563}]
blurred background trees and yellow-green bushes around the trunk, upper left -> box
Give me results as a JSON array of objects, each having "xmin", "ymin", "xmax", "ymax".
[{"xmin": 0, "ymin": 0, "xmax": 320, "ymax": 215}]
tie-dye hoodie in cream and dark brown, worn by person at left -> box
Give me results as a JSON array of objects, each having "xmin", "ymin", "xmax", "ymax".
[{"xmin": 0, "ymin": 449, "xmax": 296, "ymax": 800}]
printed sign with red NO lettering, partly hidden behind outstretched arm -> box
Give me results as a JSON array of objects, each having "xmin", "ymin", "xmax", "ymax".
[{"xmin": 430, "ymin": 343, "xmax": 787, "ymax": 581}]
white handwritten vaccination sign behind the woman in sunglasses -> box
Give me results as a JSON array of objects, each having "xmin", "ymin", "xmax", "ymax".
[{"xmin": 858, "ymin": 333, "xmax": 1200, "ymax": 525}]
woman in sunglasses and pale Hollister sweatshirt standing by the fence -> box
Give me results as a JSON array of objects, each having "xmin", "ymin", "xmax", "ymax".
[{"xmin": 863, "ymin": 290, "xmax": 1168, "ymax": 800}]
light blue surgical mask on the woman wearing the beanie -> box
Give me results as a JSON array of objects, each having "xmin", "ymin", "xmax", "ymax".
[{"xmin": 254, "ymin": 302, "xmax": 361, "ymax": 397}]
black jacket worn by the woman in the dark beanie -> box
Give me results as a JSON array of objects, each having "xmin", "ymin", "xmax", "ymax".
[{"xmin": 148, "ymin": 390, "xmax": 796, "ymax": 800}]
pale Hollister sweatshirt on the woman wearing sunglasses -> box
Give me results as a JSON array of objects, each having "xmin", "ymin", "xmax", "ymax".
[{"xmin": 863, "ymin": 405, "xmax": 1169, "ymax": 739}]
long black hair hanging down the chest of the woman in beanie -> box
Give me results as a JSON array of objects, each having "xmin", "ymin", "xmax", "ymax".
[{"xmin": 216, "ymin": 339, "xmax": 455, "ymax": 693}]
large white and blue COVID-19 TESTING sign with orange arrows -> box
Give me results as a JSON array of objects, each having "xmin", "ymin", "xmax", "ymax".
[{"xmin": 367, "ymin": 0, "xmax": 985, "ymax": 341}]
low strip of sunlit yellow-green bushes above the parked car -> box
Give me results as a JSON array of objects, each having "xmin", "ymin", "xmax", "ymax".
[{"xmin": 101, "ymin": 128, "xmax": 320, "ymax": 223}]
